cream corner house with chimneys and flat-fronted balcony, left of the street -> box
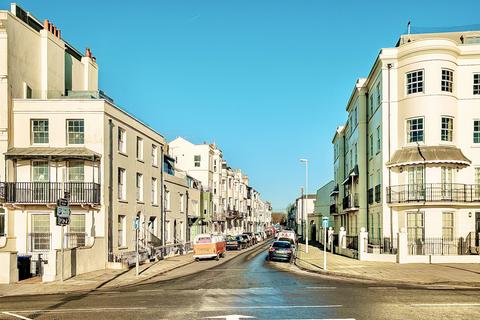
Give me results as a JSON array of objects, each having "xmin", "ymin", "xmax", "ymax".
[{"xmin": 0, "ymin": 4, "xmax": 174, "ymax": 282}]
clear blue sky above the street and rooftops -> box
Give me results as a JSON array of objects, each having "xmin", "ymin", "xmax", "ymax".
[{"xmin": 7, "ymin": 0, "xmax": 480, "ymax": 210}]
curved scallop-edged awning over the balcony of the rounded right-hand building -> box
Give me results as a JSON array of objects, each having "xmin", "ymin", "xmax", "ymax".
[{"xmin": 387, "ymin": 146, "xmax": 472, "ymax": 167}]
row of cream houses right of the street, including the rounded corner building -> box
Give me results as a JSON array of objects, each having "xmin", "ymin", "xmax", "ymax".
[{"xmin": 290, "ymin": 27, "xmax": 480, "ymax": 262}]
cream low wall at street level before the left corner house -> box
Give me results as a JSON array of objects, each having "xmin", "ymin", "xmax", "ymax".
[{"xmin": 42, "ymin": 238, "xmax": 106, "ymax": 282}]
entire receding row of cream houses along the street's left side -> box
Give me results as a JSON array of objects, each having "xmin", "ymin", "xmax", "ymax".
[{"xmin": 0, "ymin": 4, "xmax": 271, "ymax": 283}]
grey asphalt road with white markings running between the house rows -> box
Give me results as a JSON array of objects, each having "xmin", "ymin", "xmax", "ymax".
[{"xmin": 0, "ymin": 244, "xmax": 480, "ymax": 320}]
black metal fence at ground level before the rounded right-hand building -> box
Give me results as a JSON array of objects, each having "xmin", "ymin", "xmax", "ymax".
[{"xmin": 408, "ymin": 238, "xmax": 472, "ymax": 256}]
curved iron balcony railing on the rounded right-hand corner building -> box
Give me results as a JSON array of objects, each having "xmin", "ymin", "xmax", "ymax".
[{"xmin": 387, "ymin": 183, "xmax": 480, "ymax": 203}]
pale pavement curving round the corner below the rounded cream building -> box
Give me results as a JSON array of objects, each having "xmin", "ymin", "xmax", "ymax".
[{"xmin": 295, "ymin": 244, "xmax": 480, "ymax": 288}]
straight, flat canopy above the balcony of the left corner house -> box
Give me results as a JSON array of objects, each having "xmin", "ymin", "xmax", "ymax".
[{"xmin": 5, "ymin": 147, "xmax": 101, "ymax": 160}]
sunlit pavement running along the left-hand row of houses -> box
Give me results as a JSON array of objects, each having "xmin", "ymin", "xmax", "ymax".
[{"xmin": 0, "ymin": 241, "xmax": 266, "ymax": 297}]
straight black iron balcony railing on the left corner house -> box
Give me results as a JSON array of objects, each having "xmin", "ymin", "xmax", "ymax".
[{"xmin": 0, "ymin": 182, "xmax": 100, "ymax": 204}]
